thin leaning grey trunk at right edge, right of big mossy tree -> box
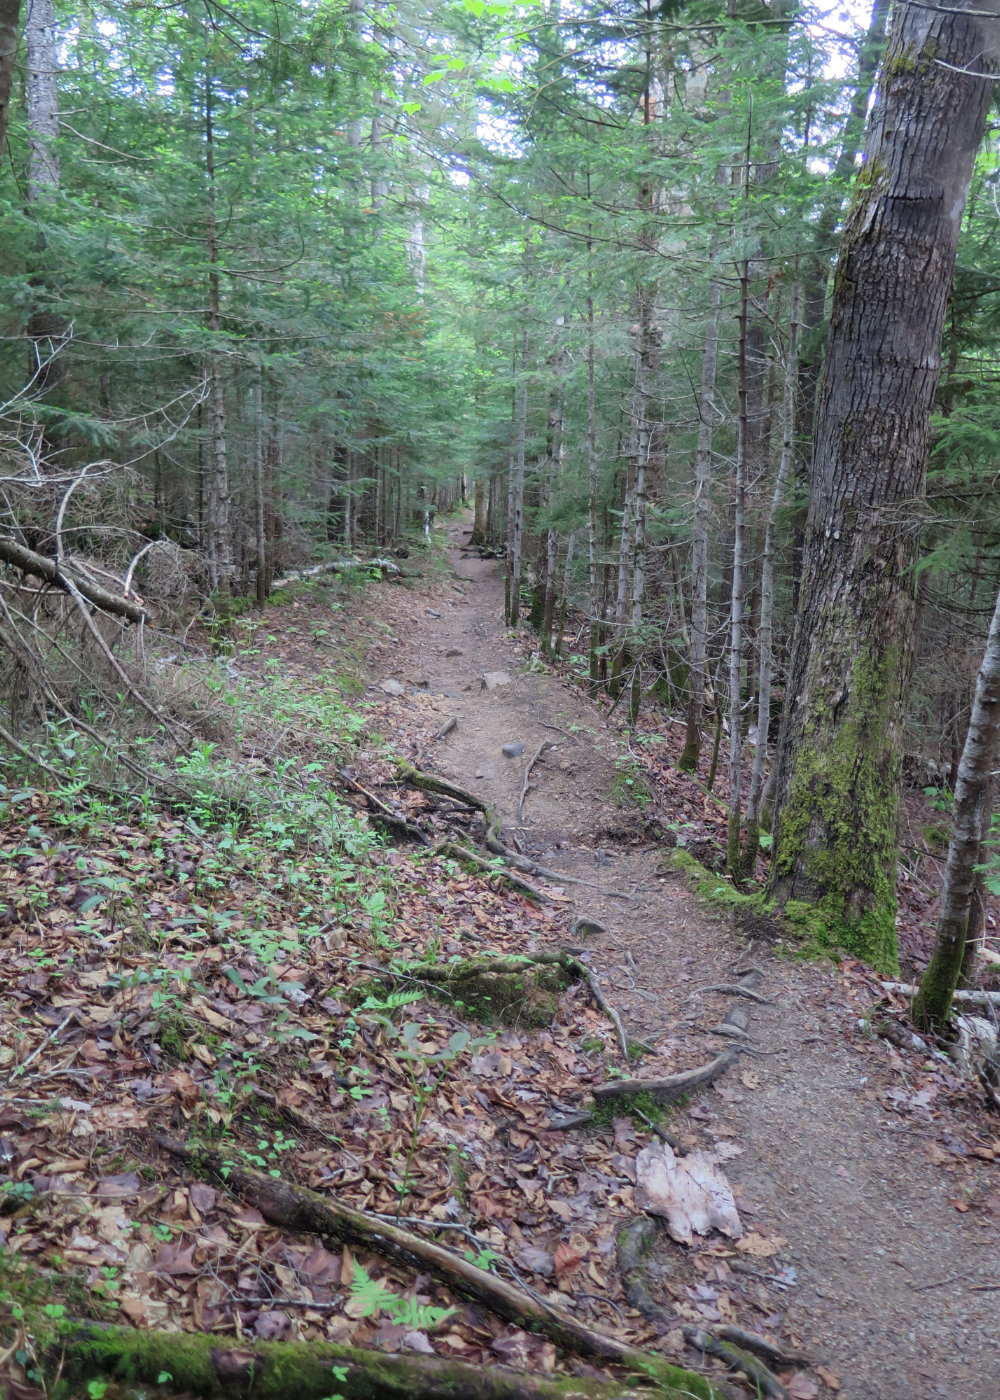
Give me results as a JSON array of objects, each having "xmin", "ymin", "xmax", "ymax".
[{"xmin": 913, "ymin": 595, "xmax": 1000, "ymax": 1030}]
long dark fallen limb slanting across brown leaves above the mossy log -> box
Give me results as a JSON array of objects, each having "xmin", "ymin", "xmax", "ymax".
[{"xmin": 155, "ymin": 1137, "xmax": 716, "ymax": 1400}]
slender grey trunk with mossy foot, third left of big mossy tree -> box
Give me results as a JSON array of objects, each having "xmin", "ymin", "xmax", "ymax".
[{"xmin": 678, "ymin": 279, "xmax": 721, "ymax": 773}]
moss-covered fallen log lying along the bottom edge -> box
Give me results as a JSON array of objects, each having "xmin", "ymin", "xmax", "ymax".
[{"xmin": 58, "ymin": 1323, "xmax": 661, "ymax": 1400}]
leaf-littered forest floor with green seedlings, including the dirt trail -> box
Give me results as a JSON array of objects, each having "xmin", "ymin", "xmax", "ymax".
[{"xmin": 0, "ymin": 519, "xmax": 1000, "ymax": 1400}]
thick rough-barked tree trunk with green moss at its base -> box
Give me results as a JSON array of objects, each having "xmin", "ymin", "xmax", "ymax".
[{"xmin": 772, "ymin": 0, "xmax": 1000, "ymax": 969}]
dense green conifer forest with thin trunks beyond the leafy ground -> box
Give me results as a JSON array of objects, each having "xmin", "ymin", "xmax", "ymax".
[{"xmin": 0, "ymin": 0, "xmax": 999, "ymax": 1019}]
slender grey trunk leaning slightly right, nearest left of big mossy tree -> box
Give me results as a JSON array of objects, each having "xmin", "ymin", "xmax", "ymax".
[{"xmin": 739, "ymin": 283, "xmax": 798, "ymax": 879}]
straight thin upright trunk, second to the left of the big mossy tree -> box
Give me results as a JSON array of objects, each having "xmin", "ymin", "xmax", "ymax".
[{"xmin": 725, "ymin": 259, "xmax": 749, "ymax": 879}]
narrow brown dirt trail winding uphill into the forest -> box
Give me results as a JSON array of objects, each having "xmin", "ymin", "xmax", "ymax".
[{"xmin": 375, "ymin": 522, "xmax": 1000, "ymax": 1400}]
